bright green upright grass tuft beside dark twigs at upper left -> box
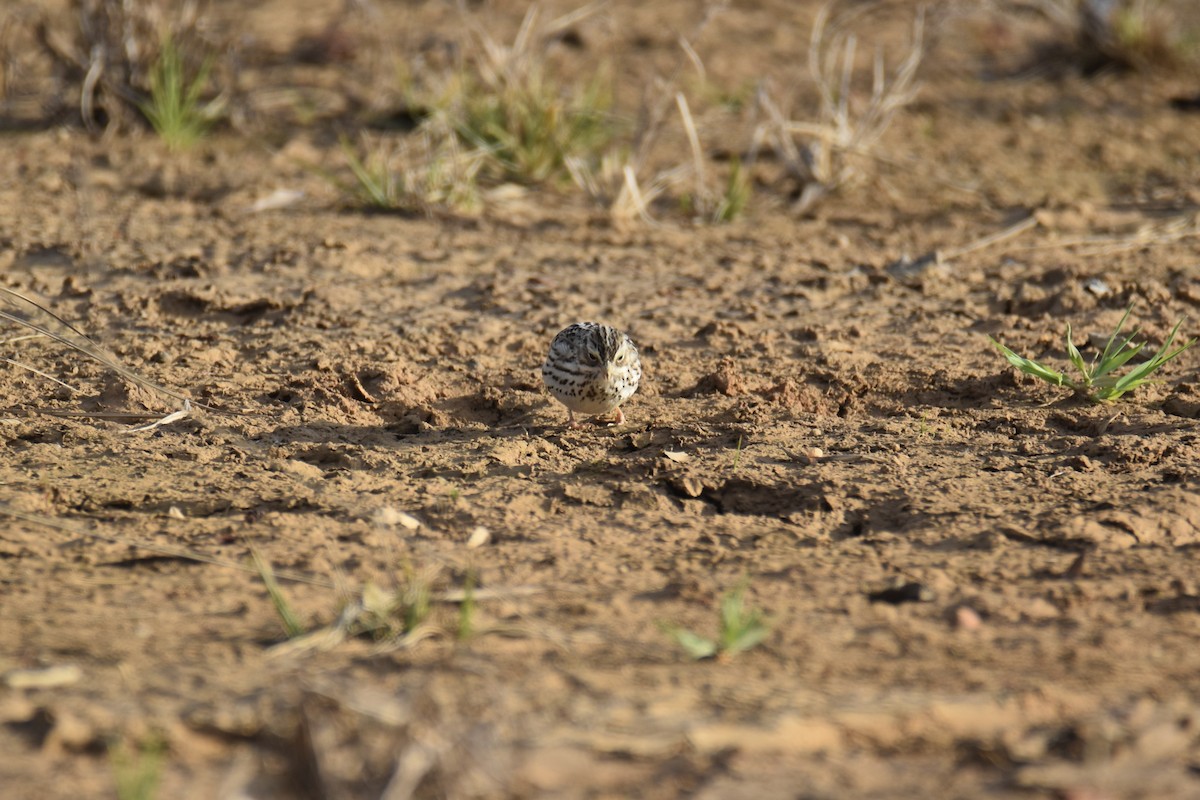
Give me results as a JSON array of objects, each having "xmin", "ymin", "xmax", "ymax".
[{"xmin": 138, "ymin": 38, "xmax": 220, "ymax": 152}]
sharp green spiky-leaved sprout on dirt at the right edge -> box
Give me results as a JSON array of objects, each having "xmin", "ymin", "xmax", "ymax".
[{"xmin": 988, "ymin": 305, "xmax": 1196, "ymax": 403}]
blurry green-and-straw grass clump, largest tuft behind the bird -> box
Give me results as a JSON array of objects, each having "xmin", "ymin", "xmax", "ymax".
[{"xmin": 334, "ymin": 6, "xmax": 617, "ymax": 212}]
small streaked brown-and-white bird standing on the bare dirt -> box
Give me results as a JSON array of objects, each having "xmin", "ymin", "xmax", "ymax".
[{"xmin": 541, "ymin": 323, "xmax": 642, "ymax": 428}]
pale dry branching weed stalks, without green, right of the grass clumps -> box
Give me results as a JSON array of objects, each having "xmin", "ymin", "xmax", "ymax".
[{"xmin": 751, "ymin": 4, "xmax": 925, "ymax": 212}]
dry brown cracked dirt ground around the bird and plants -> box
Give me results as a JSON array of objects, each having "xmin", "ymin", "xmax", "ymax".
[{"xmin": 0, "ymin": 0, "xmax": 1200, "ymax": 800}]
